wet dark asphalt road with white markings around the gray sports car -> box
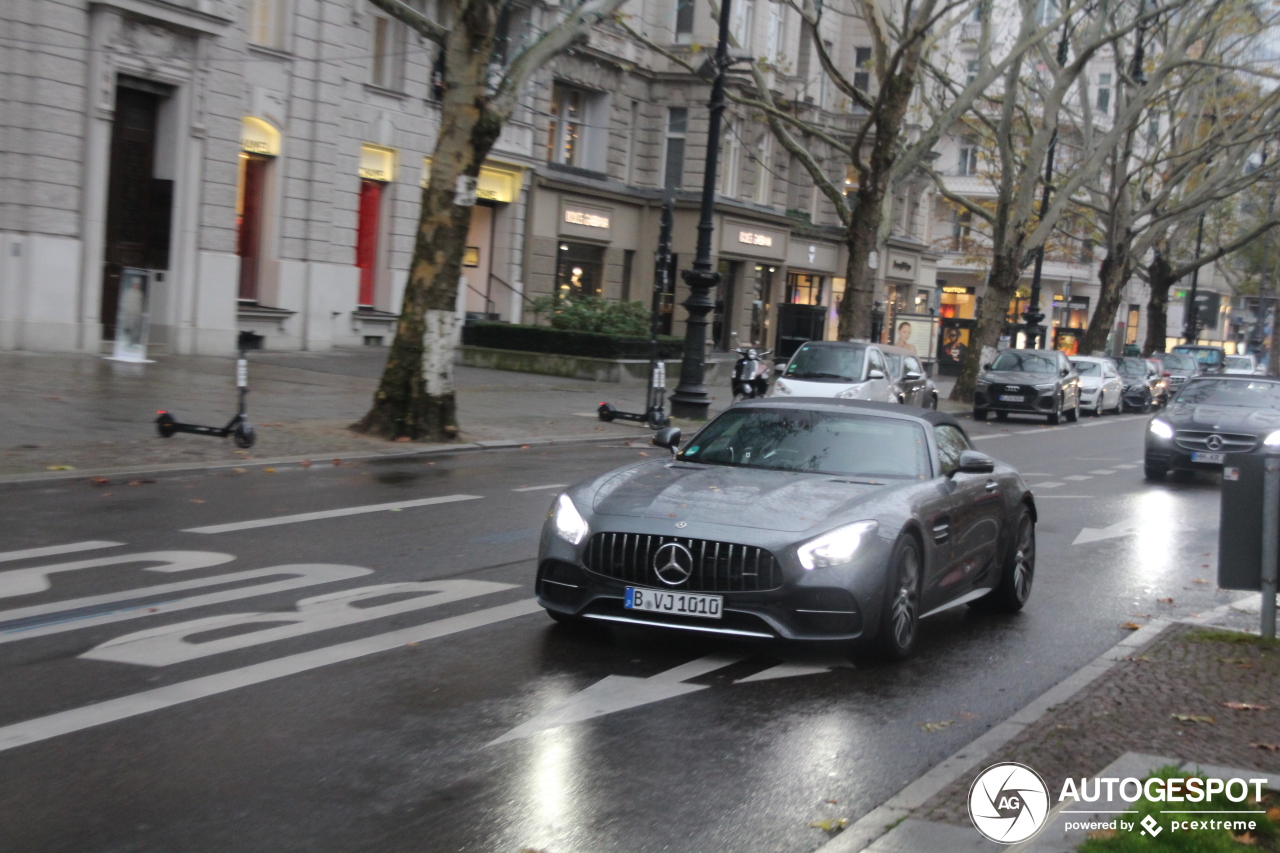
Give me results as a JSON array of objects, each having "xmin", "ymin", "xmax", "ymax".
[{"xmin": 0, "ymin": 415, "xmax": 1226, "ymax": 853}]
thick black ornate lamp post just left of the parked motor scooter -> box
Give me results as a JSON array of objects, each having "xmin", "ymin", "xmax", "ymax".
[{"xmin": 671, "ymin": 0, "xmax": 730, "ymax": 420}]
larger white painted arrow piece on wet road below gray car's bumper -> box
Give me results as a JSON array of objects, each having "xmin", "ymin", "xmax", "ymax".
[{"xmin": 489, "ymin": 654, "xmax": 746, "ymax": 747}]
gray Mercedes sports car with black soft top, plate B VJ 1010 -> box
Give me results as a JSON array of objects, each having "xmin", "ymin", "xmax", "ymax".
[{"xmin": 536, "ymin": 398, "xmax": 1036, "ymax": 658}]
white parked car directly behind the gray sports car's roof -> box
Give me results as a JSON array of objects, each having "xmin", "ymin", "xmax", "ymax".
[{"xmin": 769, "ymin": 341, "xmax": 899, "ymax": 402}]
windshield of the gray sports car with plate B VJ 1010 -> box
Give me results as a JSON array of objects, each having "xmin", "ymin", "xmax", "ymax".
[{"xmin": 680, "ymin": 409, "xmax": 931, "ymax": 480}]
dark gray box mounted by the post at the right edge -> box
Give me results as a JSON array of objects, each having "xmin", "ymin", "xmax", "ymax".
[{"xmin": 1217, "ymin": 453, "xmax": 1267, "ymax": 592}]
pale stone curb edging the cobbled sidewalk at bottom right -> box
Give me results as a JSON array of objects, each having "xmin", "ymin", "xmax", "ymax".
[{"xmin": 818, "ymin": 620, "xmax": 1175, "ymax": 853}]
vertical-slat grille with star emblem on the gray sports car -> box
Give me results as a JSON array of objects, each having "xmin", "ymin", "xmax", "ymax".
[{"xmin": 584, "ymin": 533, "xmax": 782, "ymax": 592}]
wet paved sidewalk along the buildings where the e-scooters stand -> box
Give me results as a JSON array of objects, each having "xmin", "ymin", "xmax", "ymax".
[{"xmin": 0, "ymin": 347, "xmax": 730, "ymax": 476}]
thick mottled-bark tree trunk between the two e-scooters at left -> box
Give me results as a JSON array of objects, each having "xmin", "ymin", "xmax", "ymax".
[{"xmin": 355, "ymin": 0, "xmax": 502, "ymax": 441}]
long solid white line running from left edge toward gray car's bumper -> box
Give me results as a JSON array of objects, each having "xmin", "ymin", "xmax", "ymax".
[{"xmin": 0, "ymin": 598, "xmax": 541, "ymax": 752}]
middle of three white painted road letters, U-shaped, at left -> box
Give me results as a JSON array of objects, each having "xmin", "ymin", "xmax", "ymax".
[{"xmin": 0, "ymin": 564, "xmax": 374, "ymax": 643}]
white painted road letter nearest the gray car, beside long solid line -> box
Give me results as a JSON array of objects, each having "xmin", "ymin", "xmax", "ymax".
[{"xmin": 81, "ymin": 580, "xmax": 516, "ymax": 666}]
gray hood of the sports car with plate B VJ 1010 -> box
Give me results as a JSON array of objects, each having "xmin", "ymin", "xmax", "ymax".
[{"xmin": 593, "ymin": 462, "xmax": 897, "ymax": 533}]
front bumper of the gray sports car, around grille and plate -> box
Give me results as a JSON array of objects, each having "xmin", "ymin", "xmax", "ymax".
[{"xmin": 535, "ymin": 519, "xmax": 893, "ymax": 640}]
